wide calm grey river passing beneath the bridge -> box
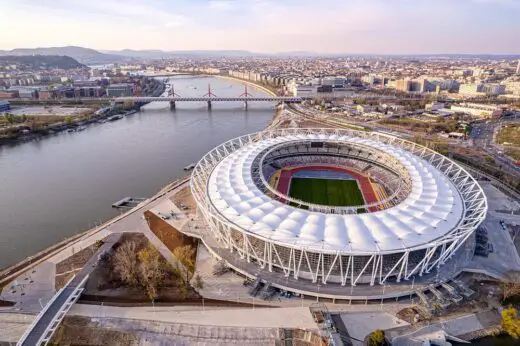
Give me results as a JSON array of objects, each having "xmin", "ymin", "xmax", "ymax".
[{"xmin": 0, "ymin": 76, "xmax": 275, "ymax": 268}]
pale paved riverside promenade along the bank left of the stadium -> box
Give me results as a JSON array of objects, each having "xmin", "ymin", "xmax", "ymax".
[{"xmin": 0, "ymin": 177, "xmax": 189, "ymax": 342}]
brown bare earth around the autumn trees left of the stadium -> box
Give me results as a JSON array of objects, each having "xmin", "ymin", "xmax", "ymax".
[{"xmin": 80, "ymin": 233, "xmax": 200, "ymax": 304}]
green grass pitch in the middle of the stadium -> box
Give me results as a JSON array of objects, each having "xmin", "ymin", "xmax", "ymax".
[{"xmin": 289, "ymin": 178, "xmax": 364, "ymax": 207}]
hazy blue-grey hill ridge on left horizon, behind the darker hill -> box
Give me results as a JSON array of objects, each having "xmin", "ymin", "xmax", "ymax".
[{"xmin": 0, "ymin": 46, "xmax": 125, "ymax": 64}]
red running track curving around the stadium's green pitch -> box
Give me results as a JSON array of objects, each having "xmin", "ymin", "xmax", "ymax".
[{"xmin": 277, "ymin": 166, "xmax": 379, "ymax": 204}]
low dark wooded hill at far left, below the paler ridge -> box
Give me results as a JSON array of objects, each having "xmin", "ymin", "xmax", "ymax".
[{"xmin": 0, "ymin": 55, "xmax": 87, "ymax": 70}]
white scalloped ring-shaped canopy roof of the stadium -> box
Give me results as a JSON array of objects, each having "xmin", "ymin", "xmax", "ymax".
[{"xmin": 208, "ymin": 134, "xmax": 463, "ymax": 253}]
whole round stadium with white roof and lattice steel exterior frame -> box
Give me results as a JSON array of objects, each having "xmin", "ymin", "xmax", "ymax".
[{"xmin": 191, "ymin": 129, "xmax": 487, "ymax": 294}]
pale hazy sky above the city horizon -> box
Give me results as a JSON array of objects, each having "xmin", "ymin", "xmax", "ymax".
[{"xmin": 0, "ymin": 0, "xmax": 520, "ymax": 54}]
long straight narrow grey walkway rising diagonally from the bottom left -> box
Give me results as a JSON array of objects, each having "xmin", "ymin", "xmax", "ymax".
[{"xmin": 20, "ymin": 234, "xmax": 121, "ymax": 346}]
